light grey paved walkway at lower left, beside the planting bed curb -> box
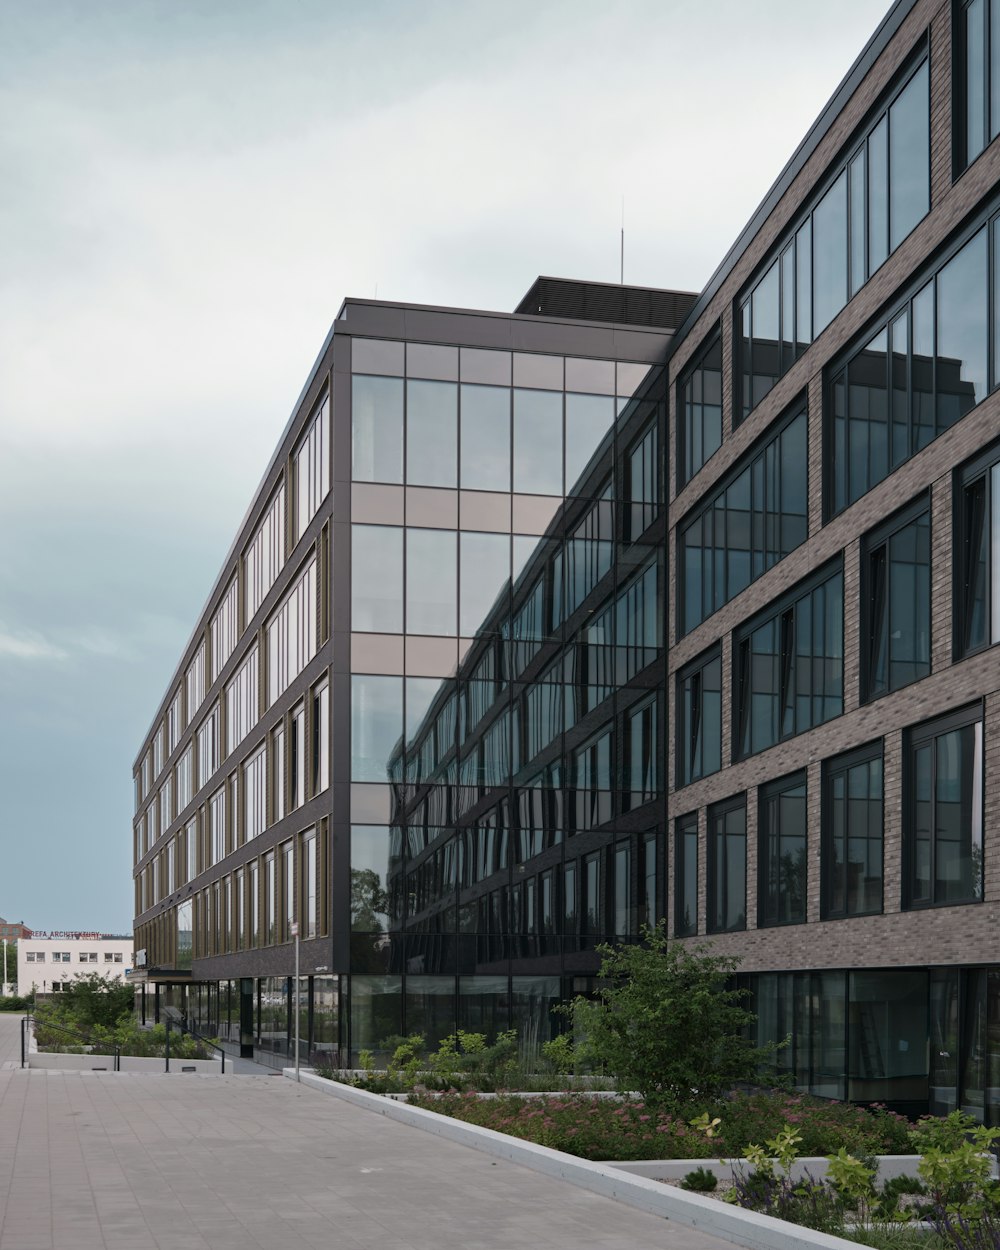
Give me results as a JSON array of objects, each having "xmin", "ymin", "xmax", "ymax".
[{"xmin": 0, "ymin": 1016, "xmax": 729, "ymax": 1250}]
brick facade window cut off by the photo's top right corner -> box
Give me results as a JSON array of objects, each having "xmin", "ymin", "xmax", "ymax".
[{"xmin": 955, "ymin": 0, "xmax": 1000, "ymax": 170}]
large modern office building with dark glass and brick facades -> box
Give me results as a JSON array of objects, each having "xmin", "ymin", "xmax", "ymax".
[{"xmin": 135, "ymin": 0, "xmax": 1000, "ymax": 1120}]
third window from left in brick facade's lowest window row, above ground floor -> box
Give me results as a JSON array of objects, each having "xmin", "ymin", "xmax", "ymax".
[{"xmin": 758, "ymin": 773, "xmax": 806, "ymax": 929}]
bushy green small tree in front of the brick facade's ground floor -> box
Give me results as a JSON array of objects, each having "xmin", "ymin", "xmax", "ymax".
[{"xmin": 571, "ymin": 921, "xmax": 775, "ymax": 1106}]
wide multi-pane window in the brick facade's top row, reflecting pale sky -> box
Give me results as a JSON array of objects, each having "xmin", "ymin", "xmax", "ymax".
[{"xmin": 738, "ymin": 56, "xmax": 930, "ymax": 418}]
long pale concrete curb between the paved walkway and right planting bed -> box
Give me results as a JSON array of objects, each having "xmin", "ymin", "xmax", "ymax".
[{"xmin": 283, "ymin": 1068, "xmax": 858, "ymax": 1250}]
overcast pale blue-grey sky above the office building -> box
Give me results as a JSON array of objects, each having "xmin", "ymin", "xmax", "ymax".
[{"xmin": 0, "ymin": 0, "xmax": 886, "ymax": 931}]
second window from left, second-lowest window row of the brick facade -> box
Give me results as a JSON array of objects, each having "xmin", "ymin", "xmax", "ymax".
[{"xmin": 733, "ymin": 568, "xmax": 844, "ymax": 756}]
